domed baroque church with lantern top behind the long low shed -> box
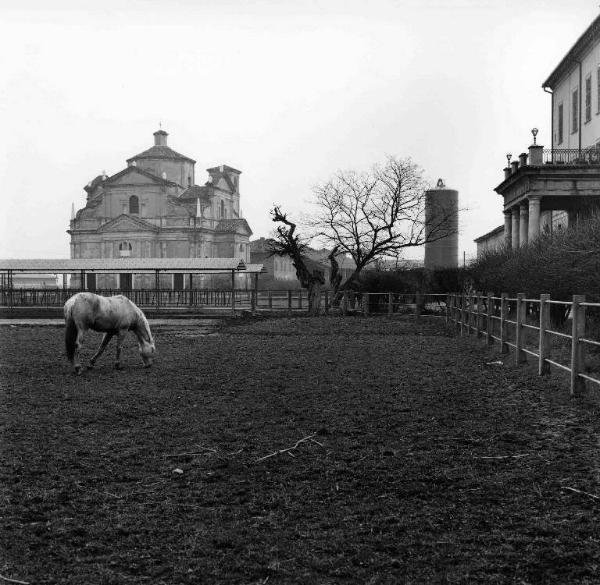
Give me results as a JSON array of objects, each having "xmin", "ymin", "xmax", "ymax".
[{"xmin": 67, "ymin": 129, "xmax": 252, "ymax": 289}]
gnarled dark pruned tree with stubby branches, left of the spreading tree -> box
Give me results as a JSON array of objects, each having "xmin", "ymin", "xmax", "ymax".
[{"xmin": 270, "ymin": 205, "xmax": 325, "ymax": 315}]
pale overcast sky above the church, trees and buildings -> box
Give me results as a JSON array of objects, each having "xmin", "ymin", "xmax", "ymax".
[{"xmin": 0, "ymin": 0, "xmax": 599, "ymax": 258}]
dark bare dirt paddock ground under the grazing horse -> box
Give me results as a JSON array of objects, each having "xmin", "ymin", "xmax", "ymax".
[{"xmin": 0, "ymin": 317, "xmax": 600, "ymax": 585}]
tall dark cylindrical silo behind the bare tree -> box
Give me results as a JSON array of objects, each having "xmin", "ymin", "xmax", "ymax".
[{"xmin": 425, "ymin": 179, "xmax": 458, "ymax": 270}]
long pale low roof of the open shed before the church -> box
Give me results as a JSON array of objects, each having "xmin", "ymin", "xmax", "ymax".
[{"xmin": 0, "ymin": 258, "xmax": 262, "ymax": 274}]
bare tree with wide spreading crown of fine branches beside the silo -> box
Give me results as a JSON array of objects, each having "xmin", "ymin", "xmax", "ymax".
[{"xmin": 308, "ymin": 157, "xmax": 457, "ymax": 290}]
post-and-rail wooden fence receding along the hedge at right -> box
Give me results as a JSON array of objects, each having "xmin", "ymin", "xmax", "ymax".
[{"xmin": 446, "ymin": 293, "xmax": 600, "ymax": 394}]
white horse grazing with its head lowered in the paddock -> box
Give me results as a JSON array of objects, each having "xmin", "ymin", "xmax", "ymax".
[{"xmin": 64, "ymin": 292, "xmax": 156, "ymax": 375}]
